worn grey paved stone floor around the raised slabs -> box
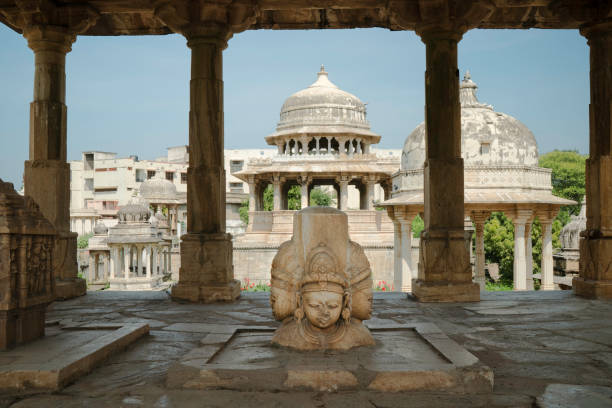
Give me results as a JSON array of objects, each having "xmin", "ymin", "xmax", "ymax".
[{"xmin": 0, "ymin": 291, "xmax": 612, "ymax": 408}]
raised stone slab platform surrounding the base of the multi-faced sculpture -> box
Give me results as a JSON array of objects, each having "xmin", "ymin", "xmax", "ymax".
[{"xmin": 166, "ymin": 323, "xmax": 493, "ymax": 393}]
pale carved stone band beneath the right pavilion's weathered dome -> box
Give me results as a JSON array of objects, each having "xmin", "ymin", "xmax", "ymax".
[{"xmin": 392, "ymin": 166, "xmax": 552, "ymax": 194}]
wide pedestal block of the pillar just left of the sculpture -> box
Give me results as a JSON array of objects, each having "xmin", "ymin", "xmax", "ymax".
[{"xmin": 172, "ymin": 233, "xmax": 240, "ymax": 303}]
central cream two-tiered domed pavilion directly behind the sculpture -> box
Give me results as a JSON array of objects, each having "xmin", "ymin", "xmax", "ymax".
[{"xmin": 234, "ymin": 67, "xmax": 399, "ymax": 280}]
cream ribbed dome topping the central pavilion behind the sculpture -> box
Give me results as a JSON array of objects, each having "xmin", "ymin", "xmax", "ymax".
[{"xmin": 276, "ymin": 66, "xmax": 370, "ymax": 132}]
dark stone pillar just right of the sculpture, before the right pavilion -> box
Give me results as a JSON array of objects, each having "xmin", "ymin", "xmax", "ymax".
[{"xmin": 412, "ymin": 26, "xmax": 480, "ymax": 302}]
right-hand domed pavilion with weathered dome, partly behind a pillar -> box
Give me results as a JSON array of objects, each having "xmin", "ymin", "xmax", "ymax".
[{"xmin": 382, "ymin": 72, "xmax": 575, "ymax": 291}]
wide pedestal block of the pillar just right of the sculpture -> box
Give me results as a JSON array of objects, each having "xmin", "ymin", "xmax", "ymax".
[{"xmin": 412, "ymin": 229, "xmax": 480, "ymax": 302}]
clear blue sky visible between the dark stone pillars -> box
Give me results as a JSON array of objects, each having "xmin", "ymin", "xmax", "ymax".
[{"xmin": 0, "ymin": 24, "xmax": 589, "ymax": 188}]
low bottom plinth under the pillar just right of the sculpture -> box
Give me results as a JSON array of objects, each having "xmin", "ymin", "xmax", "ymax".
[{"xmin": 412, "ymin": 280, "xmax": 480, "ymax": 303}]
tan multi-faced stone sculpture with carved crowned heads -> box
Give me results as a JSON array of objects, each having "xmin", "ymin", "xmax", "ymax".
[{"xmin": 270, "ymin": 207, "xmax": 374, "ymax": 350}]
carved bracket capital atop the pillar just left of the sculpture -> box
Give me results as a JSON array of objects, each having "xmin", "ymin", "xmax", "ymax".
[{"xmin": 153, "ymin": 0, "xmax": 259, "ymax": 43}]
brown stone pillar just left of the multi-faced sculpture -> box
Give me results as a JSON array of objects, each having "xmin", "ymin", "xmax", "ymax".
[{"xmin": 172, "ymin": 27, "xmax": 240, "ymax": 302}]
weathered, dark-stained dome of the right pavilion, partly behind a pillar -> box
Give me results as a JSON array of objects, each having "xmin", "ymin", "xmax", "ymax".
[{"xmin": 402, "ymin": 71, "xmax": 538, "ymax": 169}]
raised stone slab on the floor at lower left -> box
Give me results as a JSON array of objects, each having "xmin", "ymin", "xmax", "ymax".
[{"xmin": 0, "ymin": 323, "xmax": 149, "ymax": 393}]
